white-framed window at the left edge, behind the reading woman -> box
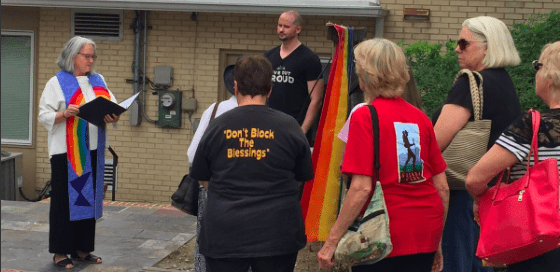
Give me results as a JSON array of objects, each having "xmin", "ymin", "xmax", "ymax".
[{"xmin": 0, "ymin": 31, "xmax": 35, "ymax": 145}]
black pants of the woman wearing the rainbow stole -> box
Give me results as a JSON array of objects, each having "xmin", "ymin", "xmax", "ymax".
[{"xmin": 49, "ymin": 151, "xmax": 97, "ymax": 254}]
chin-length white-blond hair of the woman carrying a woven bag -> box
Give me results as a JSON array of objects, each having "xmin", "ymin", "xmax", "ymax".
[{"xmin": 463, "ymin": 16, "xmax": 521, "ymax": 68}]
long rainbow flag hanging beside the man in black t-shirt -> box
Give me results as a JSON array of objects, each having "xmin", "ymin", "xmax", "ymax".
[{"xmin": 301, "ymin": 25, "xmax": 352, "ymax": 241}]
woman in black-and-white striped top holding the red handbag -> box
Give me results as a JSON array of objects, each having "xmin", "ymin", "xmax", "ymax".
[{"xmin": 466, "ymin": 41, "xmax": 560, "ymax": 272}]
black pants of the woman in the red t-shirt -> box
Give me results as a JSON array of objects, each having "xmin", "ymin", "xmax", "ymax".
[{"xmin": 352, "ymin": 252, "xmax": 435, "ymax": 272}]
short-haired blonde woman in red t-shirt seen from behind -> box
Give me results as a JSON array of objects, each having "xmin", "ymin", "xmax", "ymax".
[{"xmin": 317, "ymin": 39, "xmax": 448, "ymax": 272}]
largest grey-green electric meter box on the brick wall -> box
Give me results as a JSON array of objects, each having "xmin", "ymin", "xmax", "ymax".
[{"xmin": 158, "ymin": 91, "xmax": 183, "ymax": 128}]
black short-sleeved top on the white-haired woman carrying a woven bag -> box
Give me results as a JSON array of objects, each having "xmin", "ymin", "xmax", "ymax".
[{"xmin": 432, "ymin": 68, "xmax": 521, "ymax": 149}]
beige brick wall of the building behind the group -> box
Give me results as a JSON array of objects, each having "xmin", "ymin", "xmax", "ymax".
[{"xmin": 37, "ymin": 0, "xmax": 560, "ymax": 203}]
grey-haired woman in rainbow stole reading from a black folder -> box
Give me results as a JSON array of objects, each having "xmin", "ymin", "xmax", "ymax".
[{"xmin": 39, "ymin": 36, "xmax": 119, "ymax": 269}]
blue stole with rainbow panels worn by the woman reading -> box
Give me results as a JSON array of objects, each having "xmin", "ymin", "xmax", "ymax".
[{"xmin": 56, "ymin": 71, "xmax": 111, "ymax": 221}]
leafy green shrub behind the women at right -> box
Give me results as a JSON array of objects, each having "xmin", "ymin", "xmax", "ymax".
[{"xmin": 399, "ymin": 10, "xmax": 560, "ymax": 116}]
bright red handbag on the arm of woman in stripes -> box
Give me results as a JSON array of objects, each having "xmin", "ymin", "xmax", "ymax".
[{"xmin": 476, "ymin": 110, "xmax": 560, "ymax": 265}]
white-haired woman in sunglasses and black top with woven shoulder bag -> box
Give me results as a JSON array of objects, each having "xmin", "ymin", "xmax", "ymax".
[{"xmin": 432, "ymin": 16, "xmax": 521, "ymax": 272}]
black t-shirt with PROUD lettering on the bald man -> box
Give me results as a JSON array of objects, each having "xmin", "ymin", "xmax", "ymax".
[{"xmin": 264, "ymin": 44, "xmax": 322, "ymax": 125}]
